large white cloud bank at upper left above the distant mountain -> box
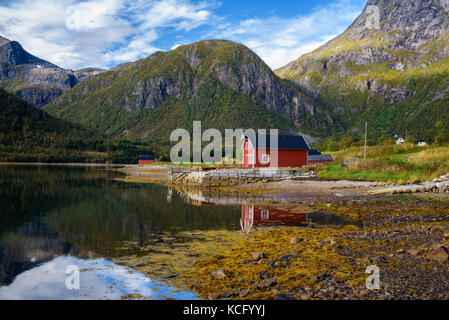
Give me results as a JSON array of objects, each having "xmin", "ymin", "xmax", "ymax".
[{"xmin": 0, "ymin": 0, "xmax": 212, "ymax": 69}]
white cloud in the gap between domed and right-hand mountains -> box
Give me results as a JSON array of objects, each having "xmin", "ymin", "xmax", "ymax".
[{"xmin": 206, "ymin": 0, "xmax": 365, "ymax": 69}]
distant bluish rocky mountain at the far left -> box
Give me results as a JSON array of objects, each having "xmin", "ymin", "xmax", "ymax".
[{"xmin": 0, "ymin": 37, "xmax": 103, "ymax": 107}]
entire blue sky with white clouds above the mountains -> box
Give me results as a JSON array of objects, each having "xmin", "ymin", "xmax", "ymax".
[{"xmin": 0, "ymin": 0, "xmax": 366, "ymax": 70}]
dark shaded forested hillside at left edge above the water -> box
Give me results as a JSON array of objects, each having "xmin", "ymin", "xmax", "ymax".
[{"xmin": 0, "ymin": 89, "xmax": 151, "ymax": 162}]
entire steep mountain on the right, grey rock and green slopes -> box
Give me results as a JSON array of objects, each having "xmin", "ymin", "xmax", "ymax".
[{"xmin": 275, "ymin": 0, "xmax": 449, "ymax": 138}]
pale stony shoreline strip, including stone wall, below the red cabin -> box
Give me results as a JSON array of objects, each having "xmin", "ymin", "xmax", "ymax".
[{"xmin": 117, "ymin": 165, "xmax": 379, "ymax": 203}]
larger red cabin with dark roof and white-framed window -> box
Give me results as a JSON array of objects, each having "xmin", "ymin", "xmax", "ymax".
[{"xmin": 242, "ymin": 135, "xmax": 310, "ymax": 168}]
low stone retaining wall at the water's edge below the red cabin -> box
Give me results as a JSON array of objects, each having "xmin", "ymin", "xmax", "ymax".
[{"xmin": 168, "ymin": 168, "xmax": 315, "ymax": 187}]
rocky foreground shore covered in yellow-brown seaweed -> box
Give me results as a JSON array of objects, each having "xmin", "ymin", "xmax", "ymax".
[{"xmin": 109, "ymin": 191, "xmax": 449, "ymax": 300}]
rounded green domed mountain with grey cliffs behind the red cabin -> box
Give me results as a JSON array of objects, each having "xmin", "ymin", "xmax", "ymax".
[{"xmin": 45, "ymin": 40, "xmax": 334, "ymax": 141}]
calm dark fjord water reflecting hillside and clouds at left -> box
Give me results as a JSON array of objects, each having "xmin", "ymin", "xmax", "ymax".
[{"xmin": 0, "ymin": 165, "xmax": 241, "ymax": 299}]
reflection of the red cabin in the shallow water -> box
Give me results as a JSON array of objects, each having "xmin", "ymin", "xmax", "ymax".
[{"xmin": 240, "ymin": 204, "xmax": 307, "ymax": 231}]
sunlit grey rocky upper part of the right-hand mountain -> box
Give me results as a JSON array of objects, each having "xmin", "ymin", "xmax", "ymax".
[{"xmin": 276, "ymin": 0, "xmax": 449, "ymax": 82}]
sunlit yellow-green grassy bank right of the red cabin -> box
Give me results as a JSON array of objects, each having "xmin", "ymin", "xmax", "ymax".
[{"xmin": 318, "ymin": 144, "xmax": 449, "ymax": 184}]
